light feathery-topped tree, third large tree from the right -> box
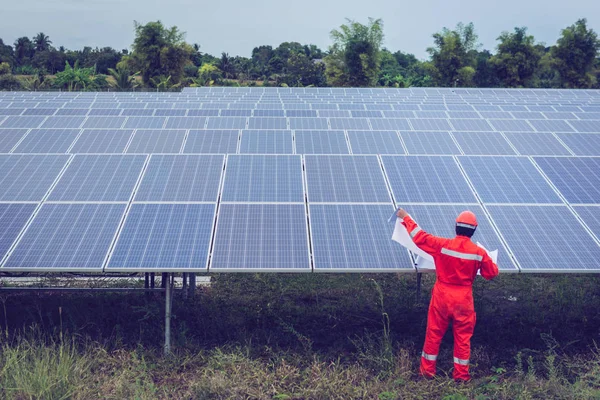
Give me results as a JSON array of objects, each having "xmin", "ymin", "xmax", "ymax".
[{"xmin": 427, "ymin": 23, "xmax": 479, "ymax": 87}]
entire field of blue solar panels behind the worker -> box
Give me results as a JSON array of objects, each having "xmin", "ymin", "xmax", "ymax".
[{"xmin": 0, "ymin": 88, "xmax": 600, "ymax": 272}]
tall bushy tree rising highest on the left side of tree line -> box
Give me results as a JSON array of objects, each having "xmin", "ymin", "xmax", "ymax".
[{"xmin": 126, "ymin": 21, "xmax": 194, "ymax": 84}]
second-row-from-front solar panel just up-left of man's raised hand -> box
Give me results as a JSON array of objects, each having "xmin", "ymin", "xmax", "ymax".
[{"xmin": 305, "ymin": 155, "xmax": 390, "ymax": 203}]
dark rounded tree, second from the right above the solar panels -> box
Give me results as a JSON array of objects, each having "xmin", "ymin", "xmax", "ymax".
[{"xmin": 490, "ymin": 27, "xmax": 542, "ymax": 87}]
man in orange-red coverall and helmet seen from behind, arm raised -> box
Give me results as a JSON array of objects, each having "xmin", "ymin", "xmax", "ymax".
[{"xmin": 397, "ymin": 209, "xmax": 498, "ymax": 381}]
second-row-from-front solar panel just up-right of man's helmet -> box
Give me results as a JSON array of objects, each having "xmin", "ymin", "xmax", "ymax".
[{"xmin": 459, "ymin": 156, "xmax": 562, "ymax": 203}]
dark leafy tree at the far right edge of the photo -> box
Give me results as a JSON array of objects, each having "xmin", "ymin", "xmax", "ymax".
[{"xmin": 552, "ymin": 18, "xmax": 600, "ymax": 88}]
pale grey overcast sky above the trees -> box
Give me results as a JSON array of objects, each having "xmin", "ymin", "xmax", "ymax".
[{"xmin": 0, "ymin": 0, "xmax": 600, "ymax": 58}]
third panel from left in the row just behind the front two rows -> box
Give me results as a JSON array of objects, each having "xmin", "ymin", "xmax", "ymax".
[{"xmin": 71, "ymin": 129, "xmax": 133, "ymax": 153}]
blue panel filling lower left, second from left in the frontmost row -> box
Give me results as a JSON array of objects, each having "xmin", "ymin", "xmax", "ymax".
[{"xmin": 3, "ymin": 204, "xmax": 126, "ymax": 271}]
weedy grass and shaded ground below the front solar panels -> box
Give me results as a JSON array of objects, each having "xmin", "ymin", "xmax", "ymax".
[{"xmin": 0, "ymin": 274, "xmax": 600, "ymax": 400}]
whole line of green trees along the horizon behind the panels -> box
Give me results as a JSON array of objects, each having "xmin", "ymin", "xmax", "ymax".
[{"xmin": 0, "ymin": 18, "xmax": 600, "ymax": 90}]
